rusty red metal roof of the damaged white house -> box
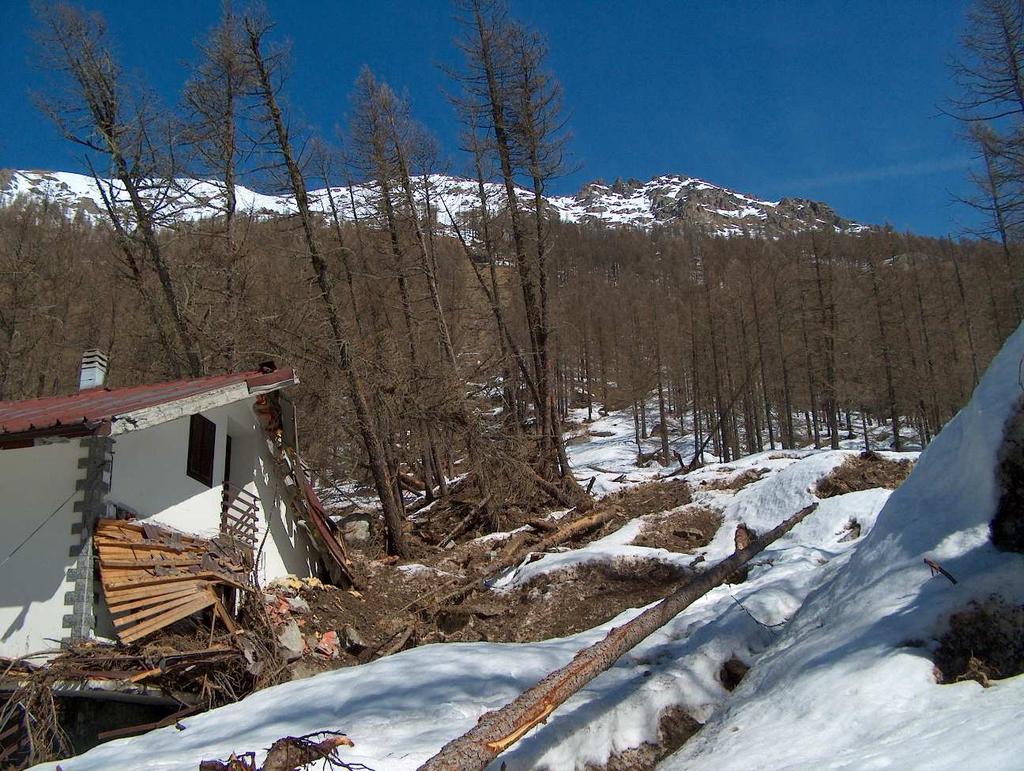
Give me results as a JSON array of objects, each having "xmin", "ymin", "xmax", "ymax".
[{"xmin": 0, "ymin": 368, "xmax": 295, "ymax": 440}]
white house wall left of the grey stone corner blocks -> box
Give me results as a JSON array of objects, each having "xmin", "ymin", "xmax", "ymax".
[{"xmin": 0, "ymin": 439, "xmax": 86, "ymax": 656}]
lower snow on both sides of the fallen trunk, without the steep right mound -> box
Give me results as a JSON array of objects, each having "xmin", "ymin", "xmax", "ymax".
[{"xmin": 29, "ymin": 437, "xmax": 913, "ymax": 771}]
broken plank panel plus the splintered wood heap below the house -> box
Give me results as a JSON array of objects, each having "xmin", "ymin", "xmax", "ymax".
[{"xmin": 0, "ymin": 519, "xmax": 289, "ymax": 768}]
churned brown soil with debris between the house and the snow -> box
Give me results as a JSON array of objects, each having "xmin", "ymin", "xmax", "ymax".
[{"xmin": 279, "ymin": 479, "xmax": 719, "ymax": 677}]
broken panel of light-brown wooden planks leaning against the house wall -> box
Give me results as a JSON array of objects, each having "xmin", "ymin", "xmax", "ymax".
[{"xmin": 94, "ymin": 519, "xmax": 253, "ymax": 644}]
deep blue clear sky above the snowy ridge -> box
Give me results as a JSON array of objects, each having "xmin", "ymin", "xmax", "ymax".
[{"xmin": 0, "ymin": 0, "xmax": 975, "ymax": 235}]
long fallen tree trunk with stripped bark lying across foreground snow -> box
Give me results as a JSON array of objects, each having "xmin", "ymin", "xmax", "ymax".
[{"xmin": 420, "ymin": 503, "xmax": 817, "ymax": 771}]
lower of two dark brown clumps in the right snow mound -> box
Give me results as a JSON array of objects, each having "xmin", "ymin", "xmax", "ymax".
[{"xmin": 935, "ymin": 595, "xmax": 1024, "ymax": 688}]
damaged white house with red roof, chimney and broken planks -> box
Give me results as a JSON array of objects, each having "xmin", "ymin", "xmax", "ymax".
[{"xmin": 0, "ymin": 351, "xmax": 347, "ymax": 658}]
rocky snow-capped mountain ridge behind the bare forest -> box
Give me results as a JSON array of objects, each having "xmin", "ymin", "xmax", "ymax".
[{"xmin": 0, "ymin": 170, "xmax": 867, "ymax": 237}]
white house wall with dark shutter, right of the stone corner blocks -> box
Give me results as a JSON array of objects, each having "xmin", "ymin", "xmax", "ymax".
[{"xmin": 108, "ymin": 398, "xmax": 316, "ymax": 582}]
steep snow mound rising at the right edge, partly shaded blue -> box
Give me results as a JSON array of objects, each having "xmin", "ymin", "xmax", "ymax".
[{"xmin": 660, "ymin": 327, "xmax": 1024, "ymax": 771}]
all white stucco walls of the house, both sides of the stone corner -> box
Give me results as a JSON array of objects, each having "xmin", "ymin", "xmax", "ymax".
[{"xmin": 0, "ymin": 399, "xmax": 317, "ymax": 656}]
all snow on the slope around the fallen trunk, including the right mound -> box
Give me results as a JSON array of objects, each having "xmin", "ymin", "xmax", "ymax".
[{"xmin": 39, "ymin": 327, "xmax": 1024, "ymax": 771}]
